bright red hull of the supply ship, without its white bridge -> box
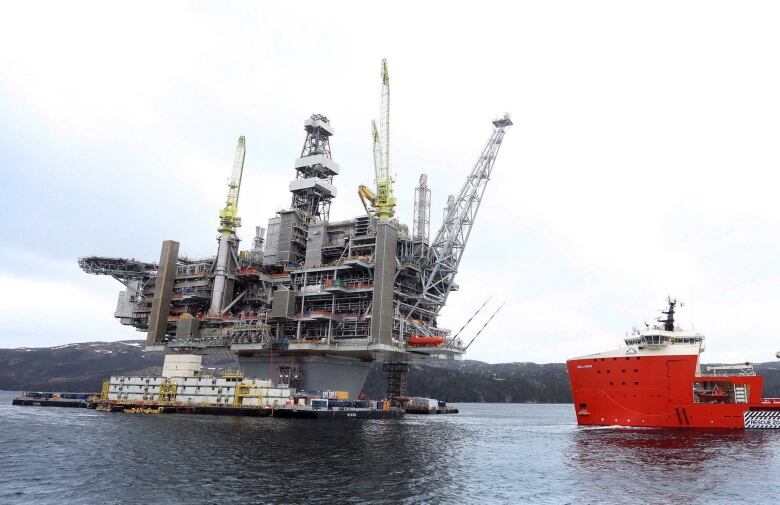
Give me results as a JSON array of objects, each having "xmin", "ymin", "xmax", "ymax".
[{"xmin": 567, "ymin": 354, "xmax": 780, "ymax": 429}]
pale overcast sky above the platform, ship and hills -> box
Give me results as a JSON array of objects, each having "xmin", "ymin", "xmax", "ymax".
[{"xmin": 0, "ymin": 0, "xmax": 780, "ymax": 362}]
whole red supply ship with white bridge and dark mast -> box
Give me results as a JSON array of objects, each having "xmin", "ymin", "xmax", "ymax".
[{"xmin": 566, "ymin": 299, "xmax": 780, "ymax": 429}]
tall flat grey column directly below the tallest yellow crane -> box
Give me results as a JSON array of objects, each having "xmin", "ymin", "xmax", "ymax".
[{"xmin": 371, "ymin": 221, "xmax": 398, "ymax": 345}]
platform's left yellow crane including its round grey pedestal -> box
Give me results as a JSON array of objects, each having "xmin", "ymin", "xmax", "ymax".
[{"xmin": 209, "ymin": 136, "xmax": 246, "ymax": 315}]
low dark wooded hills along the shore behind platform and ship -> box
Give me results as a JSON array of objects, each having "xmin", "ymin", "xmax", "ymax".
[{"xmin": 0, "ymin": 340, "xmax": 780, "ymax": 403}]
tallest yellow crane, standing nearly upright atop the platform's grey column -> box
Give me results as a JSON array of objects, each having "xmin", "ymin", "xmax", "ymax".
[{"xmin": 358, "ymin": 59, "xmax": 396, "ymax": 219}]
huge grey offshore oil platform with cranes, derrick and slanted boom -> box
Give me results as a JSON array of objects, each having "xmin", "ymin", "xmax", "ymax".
[{"xmin": 79, "ymin": 60, "xmax": 512, "ymax": 401}]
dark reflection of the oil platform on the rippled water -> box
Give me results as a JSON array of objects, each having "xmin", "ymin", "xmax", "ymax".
[{"xmin": 124, "ymin": 416, "xmax": 469, "ymax": 503}]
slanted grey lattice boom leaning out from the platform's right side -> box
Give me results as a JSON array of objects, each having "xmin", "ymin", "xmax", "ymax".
[{"xmin": 423, "ymin": 114, "xmax": 512, "ymax": 312}]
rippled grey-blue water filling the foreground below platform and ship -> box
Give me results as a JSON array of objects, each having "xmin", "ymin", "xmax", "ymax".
[{"xmin": 0, "ymin": 392, "xmax": 780, "ymax": 504}]
